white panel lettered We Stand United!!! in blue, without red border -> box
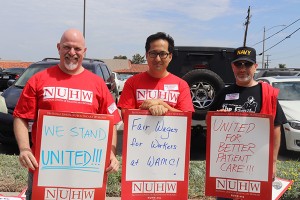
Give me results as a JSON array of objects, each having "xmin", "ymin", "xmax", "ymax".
[{"xmin": 38, "ymin": 116, "xmax": 109, "ymax": 188}]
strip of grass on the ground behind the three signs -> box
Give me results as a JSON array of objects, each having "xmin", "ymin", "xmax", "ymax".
[{"xmin": 0, "ymin": 154, "xmax": 300, "ymax": 200}]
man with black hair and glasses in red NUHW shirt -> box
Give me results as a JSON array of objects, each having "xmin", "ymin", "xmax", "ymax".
[{"xmin": 118, "ymin": 32, "xmax": 194, "ymax": 116}]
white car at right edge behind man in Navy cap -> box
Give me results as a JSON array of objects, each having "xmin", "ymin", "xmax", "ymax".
[{"xmin": 257, "ymin": 76, "xmax": 300, "ymax": 152}]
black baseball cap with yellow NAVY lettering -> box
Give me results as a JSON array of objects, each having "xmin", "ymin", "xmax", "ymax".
[{"xmin": 232, "ymin": 47, "xmax": 256, "ymax": 63}]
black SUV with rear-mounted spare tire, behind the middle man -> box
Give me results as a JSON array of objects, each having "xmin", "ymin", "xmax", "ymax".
[{"xmin": 168, "ymin": 46, "xmax": 235, "ymax": 120}]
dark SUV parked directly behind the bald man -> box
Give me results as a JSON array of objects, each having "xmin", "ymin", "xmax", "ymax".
[{"xmin": 0, "ymin": 58, "xmax": 118, "ymax": 144}]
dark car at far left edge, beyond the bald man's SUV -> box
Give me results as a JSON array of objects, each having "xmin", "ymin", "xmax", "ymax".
[{"xmin": 0, "ymin": 67, "xmax": 26, "ymax": 91}]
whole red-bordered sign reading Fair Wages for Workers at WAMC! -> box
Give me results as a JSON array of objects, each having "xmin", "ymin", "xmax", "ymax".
[{"xmin": 121, "ymin": 110, "xmax": 191, "ymax": 200}]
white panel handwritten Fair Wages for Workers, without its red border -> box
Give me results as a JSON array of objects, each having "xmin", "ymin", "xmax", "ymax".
[{"xmin": 126, "ymin": 112, "xmax": 187, "ymax": 181}]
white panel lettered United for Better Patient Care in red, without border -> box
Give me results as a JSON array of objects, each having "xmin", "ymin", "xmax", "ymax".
[{"xmin": 210, "ymin": 116, "xmax": 270, "ymax": 181}]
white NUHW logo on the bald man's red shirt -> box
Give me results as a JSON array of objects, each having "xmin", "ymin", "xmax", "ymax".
[{"xmin": 44, "ymin": 87, "xmax": 93, "ymax": 103}]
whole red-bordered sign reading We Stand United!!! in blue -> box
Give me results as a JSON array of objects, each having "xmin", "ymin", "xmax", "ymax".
[{"xmin": 32, "ymin": 110, "xmax": 113, "ymax": 200}]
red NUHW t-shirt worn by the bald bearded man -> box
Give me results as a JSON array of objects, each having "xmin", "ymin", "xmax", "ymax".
[{"xmin": 14, "ymin": 65, "xmax": 121, "ymax": 151}]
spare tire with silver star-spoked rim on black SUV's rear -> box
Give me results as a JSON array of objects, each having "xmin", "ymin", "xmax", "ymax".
[{"xmin": 182, "ymin": 69, "xmax": 225, "ymax": 120}]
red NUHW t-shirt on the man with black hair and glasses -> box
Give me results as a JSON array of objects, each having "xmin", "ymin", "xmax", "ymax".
[{"xmin": 118, "ymin": 72, "xmax": 194, "ymax": 112}]
